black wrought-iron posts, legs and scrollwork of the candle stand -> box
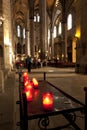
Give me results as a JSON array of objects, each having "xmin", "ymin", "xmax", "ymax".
[{"xmin": 17, "ymin": 72, "xmax": 87, "ymax": 130}]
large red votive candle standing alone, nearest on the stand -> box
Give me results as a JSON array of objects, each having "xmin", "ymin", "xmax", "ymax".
[{"xmin": 42, "ymin": 92, "xmax": 53, "ymax": 110}]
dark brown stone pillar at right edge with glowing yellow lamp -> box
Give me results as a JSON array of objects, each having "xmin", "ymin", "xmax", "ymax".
[{"xmin": 75, "ymin": 0, "xmax": 87, "ymax": 74}]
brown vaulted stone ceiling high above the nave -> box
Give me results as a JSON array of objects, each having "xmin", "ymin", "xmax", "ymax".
[{"xmin": 13, "ymin": 0, "xmax": 74, "ymax": 24}]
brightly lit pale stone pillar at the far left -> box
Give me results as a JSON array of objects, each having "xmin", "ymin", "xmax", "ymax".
[{"xmin": 2, "ymin": 0, "xmax": 13, "ymax": 69}]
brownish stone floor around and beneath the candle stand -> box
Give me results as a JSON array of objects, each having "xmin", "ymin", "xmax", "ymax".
[{"xmin": 0, "ymin": 67, "xmax": 87, "ymax": 130}]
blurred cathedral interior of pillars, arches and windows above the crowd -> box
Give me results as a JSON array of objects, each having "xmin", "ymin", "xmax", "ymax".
[{"xmin": 0, "ymin": 0, "xmax": 87, "ymax": 73}]
